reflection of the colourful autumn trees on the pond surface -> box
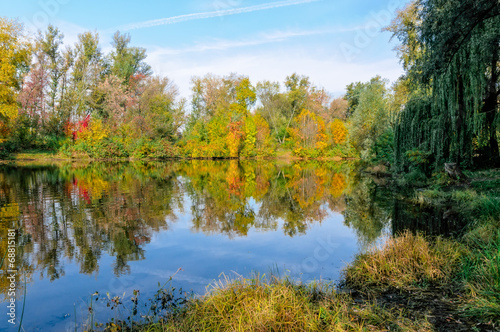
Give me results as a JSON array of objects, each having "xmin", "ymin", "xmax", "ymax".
[{"xmin": 0, "ymin": 160, "xmax": 402, "ymax": 293}]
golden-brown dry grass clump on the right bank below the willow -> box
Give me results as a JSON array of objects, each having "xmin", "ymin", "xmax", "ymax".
[{"xmin": 345, "ymin": 232, "xmax": 462, "ymax": 291}]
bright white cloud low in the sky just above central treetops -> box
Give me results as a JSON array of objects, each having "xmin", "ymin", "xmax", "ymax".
[{"xmin": 148, "ymin": 48, "xmax": 402, "ymax": 97}]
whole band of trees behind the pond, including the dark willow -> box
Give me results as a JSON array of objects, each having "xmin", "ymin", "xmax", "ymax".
[{"xmin": 0, "ymin": 0, "xmax": 500, "ymax": 169}]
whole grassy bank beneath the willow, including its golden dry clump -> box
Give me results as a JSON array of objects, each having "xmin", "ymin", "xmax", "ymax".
[{"xmin": 344, "ymin": 169, "xmax": 500, "ymax": 331}]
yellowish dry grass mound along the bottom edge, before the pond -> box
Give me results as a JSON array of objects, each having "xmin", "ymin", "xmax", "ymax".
[{"xmin": 154, "ymin": 278, "xmax": 431, "ymax": 331}]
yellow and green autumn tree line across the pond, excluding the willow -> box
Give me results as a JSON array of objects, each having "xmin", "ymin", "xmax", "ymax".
[{"xmin": 0, "ymin": 18, "xmax": 398, "ymax": 163}]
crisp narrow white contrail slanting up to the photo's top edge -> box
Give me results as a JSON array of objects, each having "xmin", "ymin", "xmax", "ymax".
[{"xmin": 119, "ymin": 0, "xmax": 319, "ymax": 31}]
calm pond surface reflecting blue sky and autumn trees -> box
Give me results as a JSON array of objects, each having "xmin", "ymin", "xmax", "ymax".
[{"xmin": 0, "ymin": 160, "xmax": 460, "ymax": 331}]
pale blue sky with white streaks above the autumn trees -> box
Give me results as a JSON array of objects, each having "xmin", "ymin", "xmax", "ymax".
[{"xmin": 0, "ymin": 0, "xmax": 408, "ymax": 98}]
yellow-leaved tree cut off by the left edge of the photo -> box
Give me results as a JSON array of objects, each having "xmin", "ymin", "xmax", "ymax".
[{"xmin": 0, "ymin": 17, "xmax": 31, "ymax": 119}]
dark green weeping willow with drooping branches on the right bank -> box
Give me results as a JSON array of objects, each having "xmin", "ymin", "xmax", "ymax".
[{"xmin": 388, "ymin": 0, "xmax": 500, "ymax": 170}]
